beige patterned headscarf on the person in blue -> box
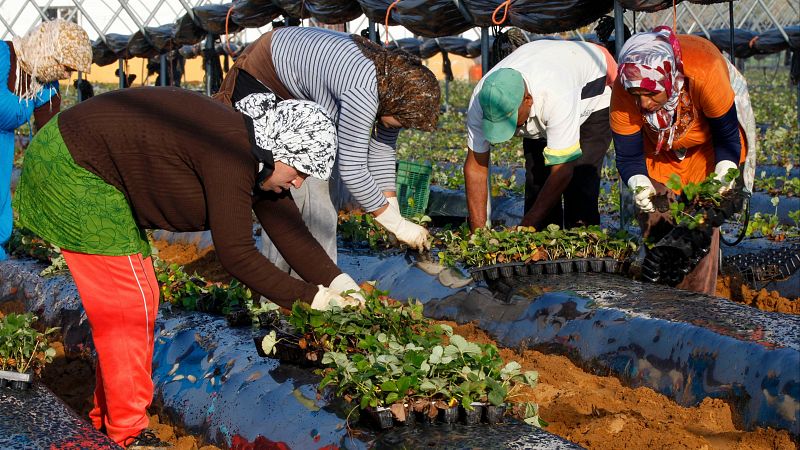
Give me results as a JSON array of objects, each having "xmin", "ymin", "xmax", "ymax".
[{"xmin": 12, "ymin": 19, "xmax": 92, "ymax": 99}]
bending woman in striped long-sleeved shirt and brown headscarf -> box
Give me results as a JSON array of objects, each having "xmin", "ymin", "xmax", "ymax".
[{"xmin": 215, "ymin": 27, "xmax": 440, "ymax": 269}]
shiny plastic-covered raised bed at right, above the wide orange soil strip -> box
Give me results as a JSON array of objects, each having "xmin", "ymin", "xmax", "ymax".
[{"xmin": 425, "ymin": 273, "xmax": 800, "ymax": 434}]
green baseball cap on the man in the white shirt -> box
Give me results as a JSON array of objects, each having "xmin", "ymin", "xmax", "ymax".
[{"xmin": 478, "ymin": 68, "xmax": 525, "ymax": 144}]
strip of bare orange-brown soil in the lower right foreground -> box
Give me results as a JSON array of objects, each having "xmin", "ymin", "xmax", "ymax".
[{"xmin": 444, "ymin": 322, "xmax": 797, "ymax": 450}]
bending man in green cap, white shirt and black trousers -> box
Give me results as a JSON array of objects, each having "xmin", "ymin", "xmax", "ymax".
[{"xmin": 464, "ymin": 40, "xmax": 616, "ymax": 230}]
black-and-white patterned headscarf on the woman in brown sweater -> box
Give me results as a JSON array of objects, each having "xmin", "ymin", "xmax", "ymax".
[{"xmin": 234, "ymin": 93, "xmax": 337, "ymax": 184}]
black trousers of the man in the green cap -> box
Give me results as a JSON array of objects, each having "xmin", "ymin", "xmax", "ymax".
[{"xmin": 522, "ymin": 108, "xmax": 611, "ymax": 228}]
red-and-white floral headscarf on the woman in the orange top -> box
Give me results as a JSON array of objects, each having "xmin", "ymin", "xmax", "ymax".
[{"xmin": 618, "ymin": 26, "xmax": 685, "ymax": 153}]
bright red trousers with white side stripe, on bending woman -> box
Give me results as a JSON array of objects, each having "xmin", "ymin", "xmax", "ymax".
[{"xmin": 62, "ymin": 250, "xmax": 159, "ymax": 447}]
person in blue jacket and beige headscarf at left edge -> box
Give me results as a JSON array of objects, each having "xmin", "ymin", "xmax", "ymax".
[{"xmin": 0, "ymin": 19, "xmax": 92, "ymax": 261}]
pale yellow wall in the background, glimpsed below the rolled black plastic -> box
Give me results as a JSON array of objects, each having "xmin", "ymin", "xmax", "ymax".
[{"xmin": 79, "ymin": 55, "xmax": 476, "ymax": 86}]
